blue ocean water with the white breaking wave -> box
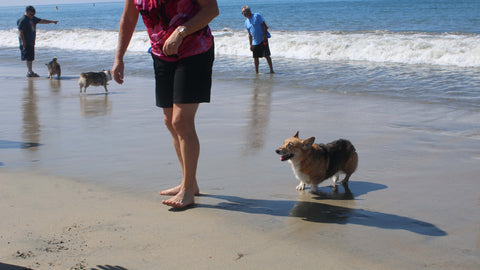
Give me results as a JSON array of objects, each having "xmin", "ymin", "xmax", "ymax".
[{"xmin": 0, "ymin": 0, "xmax": 480, "ymax": 110}]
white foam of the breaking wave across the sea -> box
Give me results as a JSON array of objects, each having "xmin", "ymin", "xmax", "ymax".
[{"xmin": 0, "ymin": 29, "xmax": 480, "ymax": 67}]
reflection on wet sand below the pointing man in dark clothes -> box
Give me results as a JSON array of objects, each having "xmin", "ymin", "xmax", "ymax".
[{"xmin": 22, "ymin": 79, "xmax": 41, "ymax": 151}]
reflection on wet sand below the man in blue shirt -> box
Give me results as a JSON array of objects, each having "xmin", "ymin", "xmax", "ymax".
[{"xmin": 246, "ymin": 77, "xmax": 272, "ymax": 152}]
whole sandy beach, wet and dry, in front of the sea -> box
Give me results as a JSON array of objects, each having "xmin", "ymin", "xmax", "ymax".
[{"xmin": 0, "ymin": 66, "xmax": 480, "ymax": 269}]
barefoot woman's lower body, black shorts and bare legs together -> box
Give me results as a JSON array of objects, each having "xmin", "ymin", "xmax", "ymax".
[{"xmin": 154, "ymin": 47, "xmax": 214, "ymax": 208}]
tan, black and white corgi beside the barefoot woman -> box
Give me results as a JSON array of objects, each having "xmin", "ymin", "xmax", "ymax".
[{"xmin": 275, "ymin": 131, "xmax": 358, "ymax": 193}]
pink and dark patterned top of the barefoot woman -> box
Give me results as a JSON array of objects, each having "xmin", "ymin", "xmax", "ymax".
[{"xmin": 135, "ymin": 0, "xmax": 213, "ymax": 61}]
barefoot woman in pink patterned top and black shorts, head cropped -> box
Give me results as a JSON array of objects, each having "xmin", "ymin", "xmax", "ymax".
[{"xmin": 112, "ymin": 0, "xmax": 219, "ymax": 208}]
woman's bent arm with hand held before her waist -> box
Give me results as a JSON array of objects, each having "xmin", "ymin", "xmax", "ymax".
[{"xmin": 162, "ymin": 0, "xmax": 219, "ymax": 55}]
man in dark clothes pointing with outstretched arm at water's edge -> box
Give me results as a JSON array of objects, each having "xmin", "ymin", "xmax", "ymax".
[{"xmin": 17, "ymin": 6, "xmax": 58, "ymax": 77}]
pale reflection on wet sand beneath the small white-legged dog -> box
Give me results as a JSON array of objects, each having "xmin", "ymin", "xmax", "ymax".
[{"xmin": 80, "ymin": 94, "xmax": 112, "ymax": 118}]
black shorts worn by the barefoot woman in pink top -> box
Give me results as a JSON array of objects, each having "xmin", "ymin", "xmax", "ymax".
[{"xmin": 152, "ymin": 45, "xmax": 215, "ymax": 108}]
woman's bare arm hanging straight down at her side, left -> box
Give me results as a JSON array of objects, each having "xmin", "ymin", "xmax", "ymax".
[{"xmin": 112, "ymin": 0, "xmax": 139, "ymax": 84}]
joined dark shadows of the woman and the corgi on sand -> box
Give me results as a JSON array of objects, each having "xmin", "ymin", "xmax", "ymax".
[{"xmin": 195, "ymin": 182, "xmax": 447, "ymax": 236}]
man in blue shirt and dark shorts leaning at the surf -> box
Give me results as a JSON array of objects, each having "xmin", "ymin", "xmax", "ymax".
[{"xmin": 242, "ymin": 6, "xmax": 274, "ymax": 73}]
